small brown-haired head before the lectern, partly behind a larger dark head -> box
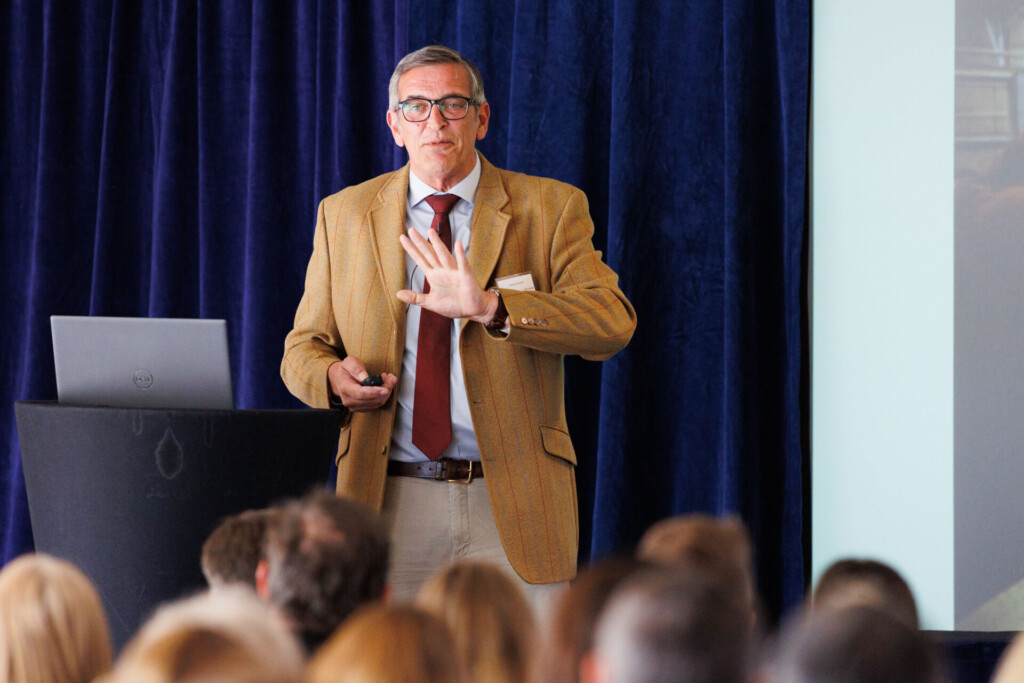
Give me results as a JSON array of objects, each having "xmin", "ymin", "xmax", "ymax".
[{"xmin": 202, "ymin": 508, "xmax": 276, "ymax": 589}]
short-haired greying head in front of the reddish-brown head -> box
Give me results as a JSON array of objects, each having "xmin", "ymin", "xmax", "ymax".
[{"xmin": 593, "ymin": 568, "xmax": 751, "ymax": 683}]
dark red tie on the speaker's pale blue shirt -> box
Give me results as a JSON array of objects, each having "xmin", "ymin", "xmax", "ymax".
[{"xmin": 413, "ymin": 195, "xmax": 459, "ymax": 460}]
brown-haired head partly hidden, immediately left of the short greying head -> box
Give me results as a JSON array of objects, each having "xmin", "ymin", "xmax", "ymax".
[{"xmin": 539, "ymin": 557, "xmax": 650, "ymax": 683}]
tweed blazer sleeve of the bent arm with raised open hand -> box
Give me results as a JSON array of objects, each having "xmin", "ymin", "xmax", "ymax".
[{"xmin": 488, "ymin": 187, "xmax": 637, "ymax": 360}]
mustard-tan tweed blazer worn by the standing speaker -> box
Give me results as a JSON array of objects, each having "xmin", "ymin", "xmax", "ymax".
[{"xmin": 281, "ymin": 155, "xmax": 636, "ymax": 583}]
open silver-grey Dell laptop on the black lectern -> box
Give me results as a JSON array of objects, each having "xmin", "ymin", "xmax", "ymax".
[{"xmin": 50, "ymin": 315, "xmax": 234, "ymax": 410}]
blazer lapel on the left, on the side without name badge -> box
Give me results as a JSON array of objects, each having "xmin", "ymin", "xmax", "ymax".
[{"xmin": 367, "ymin": 164, "xmax": 409, "ymax": 324}]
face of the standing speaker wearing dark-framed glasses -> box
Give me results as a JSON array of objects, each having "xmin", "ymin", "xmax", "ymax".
[{"xmin": 387, "ymin": 63, "xmax": 490, "ymax": 190}]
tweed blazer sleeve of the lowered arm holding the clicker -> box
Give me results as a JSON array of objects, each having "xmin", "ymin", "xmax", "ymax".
[{"xmin": 281, "ymin": 198, "xmax": 345, "ymax": 408}]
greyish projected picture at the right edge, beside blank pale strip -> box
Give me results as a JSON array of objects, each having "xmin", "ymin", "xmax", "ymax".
[{"xmin": 954, "ymin": 0, "xmax": 1024, "ymax": 631}]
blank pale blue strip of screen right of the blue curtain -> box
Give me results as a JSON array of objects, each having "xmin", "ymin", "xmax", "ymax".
[{"xmin": 811, "ymin": 0, "xmax": 954, "ymax": 629}]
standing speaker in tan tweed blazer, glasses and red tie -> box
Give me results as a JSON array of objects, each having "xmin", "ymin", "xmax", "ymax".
[{"xmin": 282, "ymin": 46, "xmax": 636, "ymax": 600}]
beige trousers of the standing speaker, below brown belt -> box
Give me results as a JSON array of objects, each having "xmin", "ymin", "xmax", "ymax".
[{"xmin": 383, "ymin": 476, "xmax": 568, "ymax": 616}]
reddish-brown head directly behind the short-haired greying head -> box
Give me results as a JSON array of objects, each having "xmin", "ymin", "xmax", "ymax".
[{"xmin": 637, "ymin": 513, "xmax": 757, "ymax": 625}]
